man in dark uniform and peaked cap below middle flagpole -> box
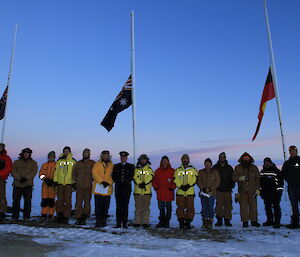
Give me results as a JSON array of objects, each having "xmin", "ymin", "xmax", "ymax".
[{"xmin": 112, "ymin": 151, "xmax": 134, "ymax": 228}]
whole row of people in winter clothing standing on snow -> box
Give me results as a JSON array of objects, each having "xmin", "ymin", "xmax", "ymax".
[{"xmin": 0, "ymin": 144, "xmax": 300, "ymax": 229}]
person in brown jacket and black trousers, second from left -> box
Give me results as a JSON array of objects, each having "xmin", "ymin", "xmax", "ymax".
[{"xmin": 12, "ymin": 148, "xmax": 38, "ymax": 220}]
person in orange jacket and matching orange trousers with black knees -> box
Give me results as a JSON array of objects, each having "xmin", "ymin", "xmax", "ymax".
[{"xmin": 39, "ymin": 151, "xmax": 56, "ymax": 220}]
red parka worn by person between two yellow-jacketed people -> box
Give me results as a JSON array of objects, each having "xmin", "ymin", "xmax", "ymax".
[{"xmin": 152, "ymin": 164, "xmax": 176, "ymax": 202}]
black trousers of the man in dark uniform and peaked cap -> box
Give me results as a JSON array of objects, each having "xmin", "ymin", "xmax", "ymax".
[{"xmin": 116, "ymin": 190, "xmax": 131, "ymax": 226}]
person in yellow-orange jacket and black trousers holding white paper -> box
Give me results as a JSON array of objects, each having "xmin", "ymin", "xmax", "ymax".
[{"xmin": 92, "ymin": 150, "xmax": 114, "ymax": 227}]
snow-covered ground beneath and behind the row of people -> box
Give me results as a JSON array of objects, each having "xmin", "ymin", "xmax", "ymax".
[{"xmin": 0, "ymin": 175, "xmax": 300, "ymax": 256}]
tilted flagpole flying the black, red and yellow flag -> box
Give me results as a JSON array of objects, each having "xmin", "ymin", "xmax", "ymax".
[{"xmin": 265, "ymin": 0, "xmax": 286, "ymax": 161}]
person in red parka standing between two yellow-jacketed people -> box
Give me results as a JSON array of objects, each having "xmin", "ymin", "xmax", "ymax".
[{"xmin": 152, "ymin": 156, "xmax": 176, "ymax": 228}]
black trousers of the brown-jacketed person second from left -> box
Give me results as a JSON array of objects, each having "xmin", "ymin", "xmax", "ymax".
[{"xmin": 12, "ymin": 186, "xmax": 32, "ymax": 219}]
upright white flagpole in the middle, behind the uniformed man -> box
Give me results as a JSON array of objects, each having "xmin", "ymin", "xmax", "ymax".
[{"xmin": 131, "ymin": 11, "xmax": 136, "ymax": 165}]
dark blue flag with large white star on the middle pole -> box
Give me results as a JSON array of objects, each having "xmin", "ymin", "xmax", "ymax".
[{"xmin": 101, "ymin": 75, "xmax": 132, "ymax": 132}]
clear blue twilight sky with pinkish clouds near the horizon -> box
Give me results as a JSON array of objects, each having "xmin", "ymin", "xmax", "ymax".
[{"xmin": 0, "ymin": 0, "xmax": 300, "ymax": 168}]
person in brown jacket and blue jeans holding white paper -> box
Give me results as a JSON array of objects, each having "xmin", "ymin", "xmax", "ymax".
[{"xmin": 197, "ymin": 158, "xmax": 220, "ymax": 229}]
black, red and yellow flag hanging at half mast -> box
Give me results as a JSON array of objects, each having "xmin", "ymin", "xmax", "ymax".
[{"xmin": 252, "ymin": 67, "xmax": 276, "ymax": 141}]
